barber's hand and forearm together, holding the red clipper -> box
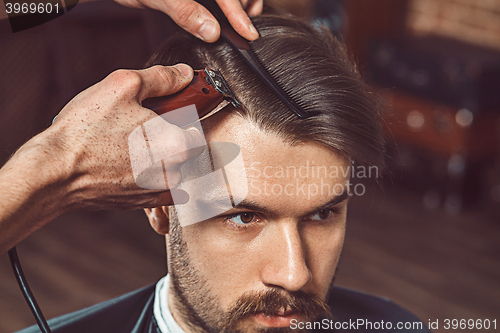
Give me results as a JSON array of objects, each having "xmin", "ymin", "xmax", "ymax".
[{"xmin": 0, "ymin": 65, "xmax": 205, "ymax": 254}]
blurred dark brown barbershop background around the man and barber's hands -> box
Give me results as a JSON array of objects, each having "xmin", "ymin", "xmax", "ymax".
[{"xmin": 0, "ymin": 0, "xmax": 500, "ymax": 332}]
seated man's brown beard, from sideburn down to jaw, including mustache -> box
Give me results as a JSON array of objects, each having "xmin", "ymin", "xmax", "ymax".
[{"xmin": 168, "ymin": 209, "xmax": 331, "ymax": 333}]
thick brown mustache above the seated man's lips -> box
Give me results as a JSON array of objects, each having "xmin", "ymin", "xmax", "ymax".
[{"xmin": 229, "ymin": 288, "xmax": 331, "ymax": 321}]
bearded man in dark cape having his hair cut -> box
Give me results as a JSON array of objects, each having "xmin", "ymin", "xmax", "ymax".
[{"xmin": 5, "ymin": 10, "xmax": 426, "ymax": 333}]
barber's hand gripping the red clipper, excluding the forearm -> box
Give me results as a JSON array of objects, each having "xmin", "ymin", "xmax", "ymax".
[{"xmin": 46, "ymin": 65, "xmax": 204, "ymax": 210}]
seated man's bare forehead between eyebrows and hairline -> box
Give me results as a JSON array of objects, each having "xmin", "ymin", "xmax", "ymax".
[{"xmin": 201, "ymin": 112, "xmax": 349, "ymax": 214}]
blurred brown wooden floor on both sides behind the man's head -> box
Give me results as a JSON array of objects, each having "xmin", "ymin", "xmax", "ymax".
[{"xmin": 0, "ymin": 185, "xmax": 500, "ymax": 333}]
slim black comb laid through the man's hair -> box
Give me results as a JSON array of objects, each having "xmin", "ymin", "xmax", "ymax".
[{"xmin": 196, "ymin": 0, "xmax": 318, "ymax": 118}]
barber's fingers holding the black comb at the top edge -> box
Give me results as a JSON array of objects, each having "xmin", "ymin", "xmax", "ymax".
[{"xmin": 115, "ymin": 0, "xmax": 264, "ymax": 43}]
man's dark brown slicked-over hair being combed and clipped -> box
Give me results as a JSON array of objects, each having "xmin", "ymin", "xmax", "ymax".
[{"xmin": 148, "ymin": 14, "xmax": 384, "ymax": 167}]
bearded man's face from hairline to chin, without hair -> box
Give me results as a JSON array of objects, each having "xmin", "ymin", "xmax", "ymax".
[{"xmin": 167, "ymin": 113, "xmax": 349, "ymax": 332}]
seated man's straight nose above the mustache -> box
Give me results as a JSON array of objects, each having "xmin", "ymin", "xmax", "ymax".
[{"xmin": 261, "ymin": 223, "xmax": 312, "ymax": 291}]
